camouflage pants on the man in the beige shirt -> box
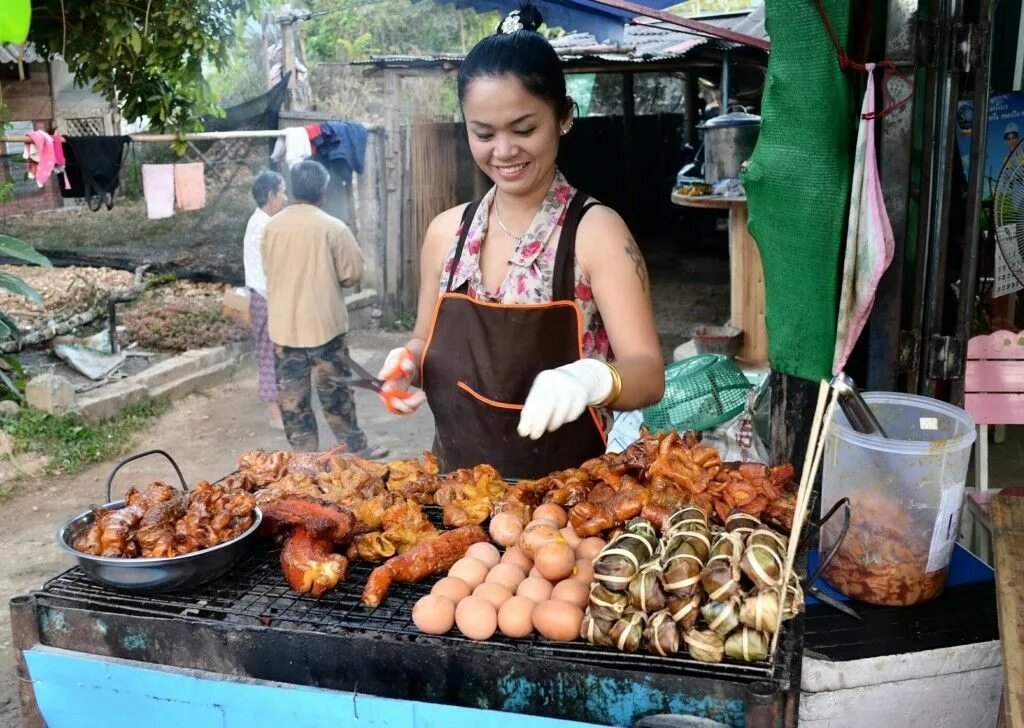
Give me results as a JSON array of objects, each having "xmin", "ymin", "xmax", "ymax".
[{"xmin": 273, "ymin": 334, "xmax": 367, "ymax": 453}]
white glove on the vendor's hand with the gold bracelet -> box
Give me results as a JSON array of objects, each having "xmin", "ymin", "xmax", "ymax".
[{"xmin": 518, "ymin": 359, "xmax": 614, "ymax": 440}]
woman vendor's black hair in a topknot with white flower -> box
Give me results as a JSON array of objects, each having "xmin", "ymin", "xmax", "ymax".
[{"xmin": 459, "ymin": 4, "xmax": 571, "ymax": 121}]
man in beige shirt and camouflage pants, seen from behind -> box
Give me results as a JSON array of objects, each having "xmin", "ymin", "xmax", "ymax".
[{"xmin": 262, "ymin": 161, "xmax": 387, "ymax": 458}]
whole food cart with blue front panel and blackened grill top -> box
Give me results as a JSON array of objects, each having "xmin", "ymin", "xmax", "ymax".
[{"xmin": 11, "ymin": 550, "xmax": 802, "ymax": 728}]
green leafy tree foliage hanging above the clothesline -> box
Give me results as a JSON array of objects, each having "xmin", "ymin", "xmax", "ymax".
[{"xmin": 29, "ymin": 0, "xmax": 262, "ymax": 130}]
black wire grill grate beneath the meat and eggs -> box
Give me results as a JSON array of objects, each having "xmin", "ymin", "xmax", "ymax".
[{"xmin": 38, "ymin": 549, "xmax": 778, "ymax": 682}]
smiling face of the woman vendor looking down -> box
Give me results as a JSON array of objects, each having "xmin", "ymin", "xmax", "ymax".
[{"xmin": 462, "ymin": 76, "xmax": 569, "ymax": 195}]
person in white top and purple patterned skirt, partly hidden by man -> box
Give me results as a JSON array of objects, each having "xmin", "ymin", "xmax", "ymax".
[{"xmin": 242, "ymin": 170, "xmax": 288, "ymax": 430}]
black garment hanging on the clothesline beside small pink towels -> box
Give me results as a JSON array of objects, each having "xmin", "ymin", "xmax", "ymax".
[{"xmin": 60, "ymin": 136, "xmax": 131, "ymax": 212}]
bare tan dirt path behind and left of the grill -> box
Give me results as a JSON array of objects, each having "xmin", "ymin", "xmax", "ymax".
[{"xmin": 0, "ymin": 332, "xmax": 433, "ymax": 726}]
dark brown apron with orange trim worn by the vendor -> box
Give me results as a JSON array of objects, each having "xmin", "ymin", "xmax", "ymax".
[{"xmin": 421, "ymin": 192, "xmax": 605, "ymax": 478}]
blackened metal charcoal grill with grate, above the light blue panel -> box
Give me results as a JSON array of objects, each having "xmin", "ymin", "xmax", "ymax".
[{"xmin": 18, "ymin": 546, "xmax": 802, "ymax": 725}]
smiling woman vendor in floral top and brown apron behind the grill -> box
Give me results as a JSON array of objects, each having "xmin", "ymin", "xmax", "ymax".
[{"xmin": 380, "ymin": 5, "xmax": 665, "ymax": 478}]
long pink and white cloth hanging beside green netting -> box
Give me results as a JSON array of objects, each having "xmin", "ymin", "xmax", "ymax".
[{"xmin": 833, "ymin": 63, "xmax": 895, "ymax": 374}]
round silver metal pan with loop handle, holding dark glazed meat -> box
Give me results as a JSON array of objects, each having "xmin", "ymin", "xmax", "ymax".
[{"xmin": 57, "ymin": 449, "xmax": 263, "ymax": 592}]
